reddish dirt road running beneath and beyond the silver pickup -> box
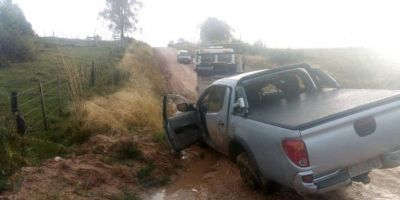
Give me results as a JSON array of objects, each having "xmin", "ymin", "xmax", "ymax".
[{"xmin": 154, "ymin": 48, "xmax": 400, "ymax": 200}]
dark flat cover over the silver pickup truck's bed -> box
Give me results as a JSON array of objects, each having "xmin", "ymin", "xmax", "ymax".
[{"xmin": 248, "ymin": 89, "xmax": 400, "ymax": 130}]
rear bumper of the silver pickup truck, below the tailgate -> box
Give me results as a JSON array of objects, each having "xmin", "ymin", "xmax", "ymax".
[{"xmin": 293, "ymin": 149, "xmax": 400, "ymax": 194}]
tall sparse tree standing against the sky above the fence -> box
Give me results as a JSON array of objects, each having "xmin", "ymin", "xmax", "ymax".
[{"xmin": 99, "ymin": 0, "xmax": 142, "ymax": 40}]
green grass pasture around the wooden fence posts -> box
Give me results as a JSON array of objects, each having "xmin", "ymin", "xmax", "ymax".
[{"xmin": 0, "ymin": 38, "xmax": 123, "ymax": 191}]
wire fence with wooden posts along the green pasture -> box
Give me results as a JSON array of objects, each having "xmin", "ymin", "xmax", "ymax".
[{"xmin": 0, "ymin": 50, "xmax": 130, "ymax": 134}]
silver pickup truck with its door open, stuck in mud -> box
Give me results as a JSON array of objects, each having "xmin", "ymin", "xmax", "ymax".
[{"xmin": 164, "ymin": 64, "xmax": 400, "ymax": 194}]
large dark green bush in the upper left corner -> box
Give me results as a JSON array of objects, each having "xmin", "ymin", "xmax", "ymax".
[{"xmin": 0, "ymin": 0, "xmax": 35, "ymax": 66}]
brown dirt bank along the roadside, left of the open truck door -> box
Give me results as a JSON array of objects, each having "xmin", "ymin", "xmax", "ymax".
[{"xmin": 0, "ymin": 133, "xmax": 175, "ymax": 200}]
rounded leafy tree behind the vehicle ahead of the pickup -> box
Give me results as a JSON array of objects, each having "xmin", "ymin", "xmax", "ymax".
[{"xmin": 200, "ymin": 17, "xmax": 233, "ymax": 43}]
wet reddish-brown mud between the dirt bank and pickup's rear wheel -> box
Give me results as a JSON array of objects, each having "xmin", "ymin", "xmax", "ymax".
[{"xmin": 148, "ymin": 147, "xmax": 303, "ymax": 200}]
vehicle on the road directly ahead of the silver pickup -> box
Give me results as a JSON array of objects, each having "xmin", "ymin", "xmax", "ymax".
[{"xmin": 196, "ymin": 47, "xmax": 244, "ymax": 94}]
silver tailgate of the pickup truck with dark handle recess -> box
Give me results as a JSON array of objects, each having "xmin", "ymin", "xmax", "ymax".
[{"xmin": 301, "ymin": 96, "xmax": 400, "ymax": 177}]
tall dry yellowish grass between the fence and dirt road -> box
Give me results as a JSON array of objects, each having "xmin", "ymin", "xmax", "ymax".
[{"xmin": 75, "ymin": 43, "xmax": 165, "ymax": 133}]
